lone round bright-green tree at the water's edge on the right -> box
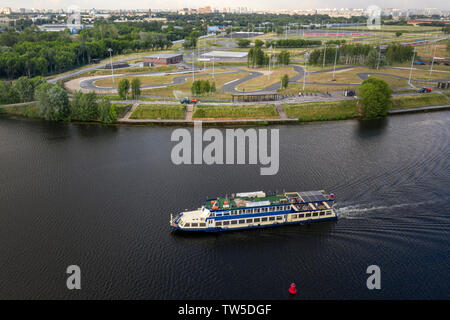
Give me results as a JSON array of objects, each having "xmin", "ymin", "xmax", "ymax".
[{"xmin": 359, "ymin": 78, "xmax": 392, "ymax": 119}]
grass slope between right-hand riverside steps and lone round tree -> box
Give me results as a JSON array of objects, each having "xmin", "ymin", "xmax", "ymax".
[{"xmin": 283, "ymin": 100, "xmax": 359, "ymax": 121}]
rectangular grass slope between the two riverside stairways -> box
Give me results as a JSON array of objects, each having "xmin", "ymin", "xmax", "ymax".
[{"xmin": 193, "ymin": 105, "xmax": 279, "ymax": 119}]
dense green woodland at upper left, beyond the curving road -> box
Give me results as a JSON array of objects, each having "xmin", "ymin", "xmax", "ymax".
[{"xmin": 0, "ymin": 24, "xmax": 172, "ymax": 79}]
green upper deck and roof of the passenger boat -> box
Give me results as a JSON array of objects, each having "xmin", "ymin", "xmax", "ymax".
[{"xmin": 204, "ymin": 190, "xmax": 330, "ymax": 210}]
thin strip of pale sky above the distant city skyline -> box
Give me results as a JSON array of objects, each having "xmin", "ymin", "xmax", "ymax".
[{"xmin": 0, "ymin": 0, "xmax": 450, "ymax": 10}]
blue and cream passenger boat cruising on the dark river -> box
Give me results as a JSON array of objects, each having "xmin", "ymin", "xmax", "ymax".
[{"xmin": 170, "ymin": 190, "xmax": 337, "ymax": 232}]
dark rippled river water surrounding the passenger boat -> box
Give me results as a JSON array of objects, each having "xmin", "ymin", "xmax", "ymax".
[{"xmin": 0, "ymin": 111, "xmax": 450, "ymax": 299}]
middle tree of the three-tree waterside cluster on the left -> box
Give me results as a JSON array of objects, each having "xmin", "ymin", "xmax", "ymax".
[{"xmin": 70, "ymin": 91, "xmax": 98, "ymax": 121}]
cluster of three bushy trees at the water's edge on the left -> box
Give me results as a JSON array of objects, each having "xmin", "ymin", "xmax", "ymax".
[{"xmin": 35, "ymin": 82, "xmax": 117, "ymax": 123}]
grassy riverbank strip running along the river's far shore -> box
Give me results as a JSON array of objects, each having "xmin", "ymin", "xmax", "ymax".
[{"xmin": 0, "ymin": 94, "xmax": 450, "ymax": 126}]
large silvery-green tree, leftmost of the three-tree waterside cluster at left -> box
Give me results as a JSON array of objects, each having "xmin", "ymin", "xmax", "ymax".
[{"xmin": 35, "ymin": 82, "xmax": 70, "ymax": 121}]
